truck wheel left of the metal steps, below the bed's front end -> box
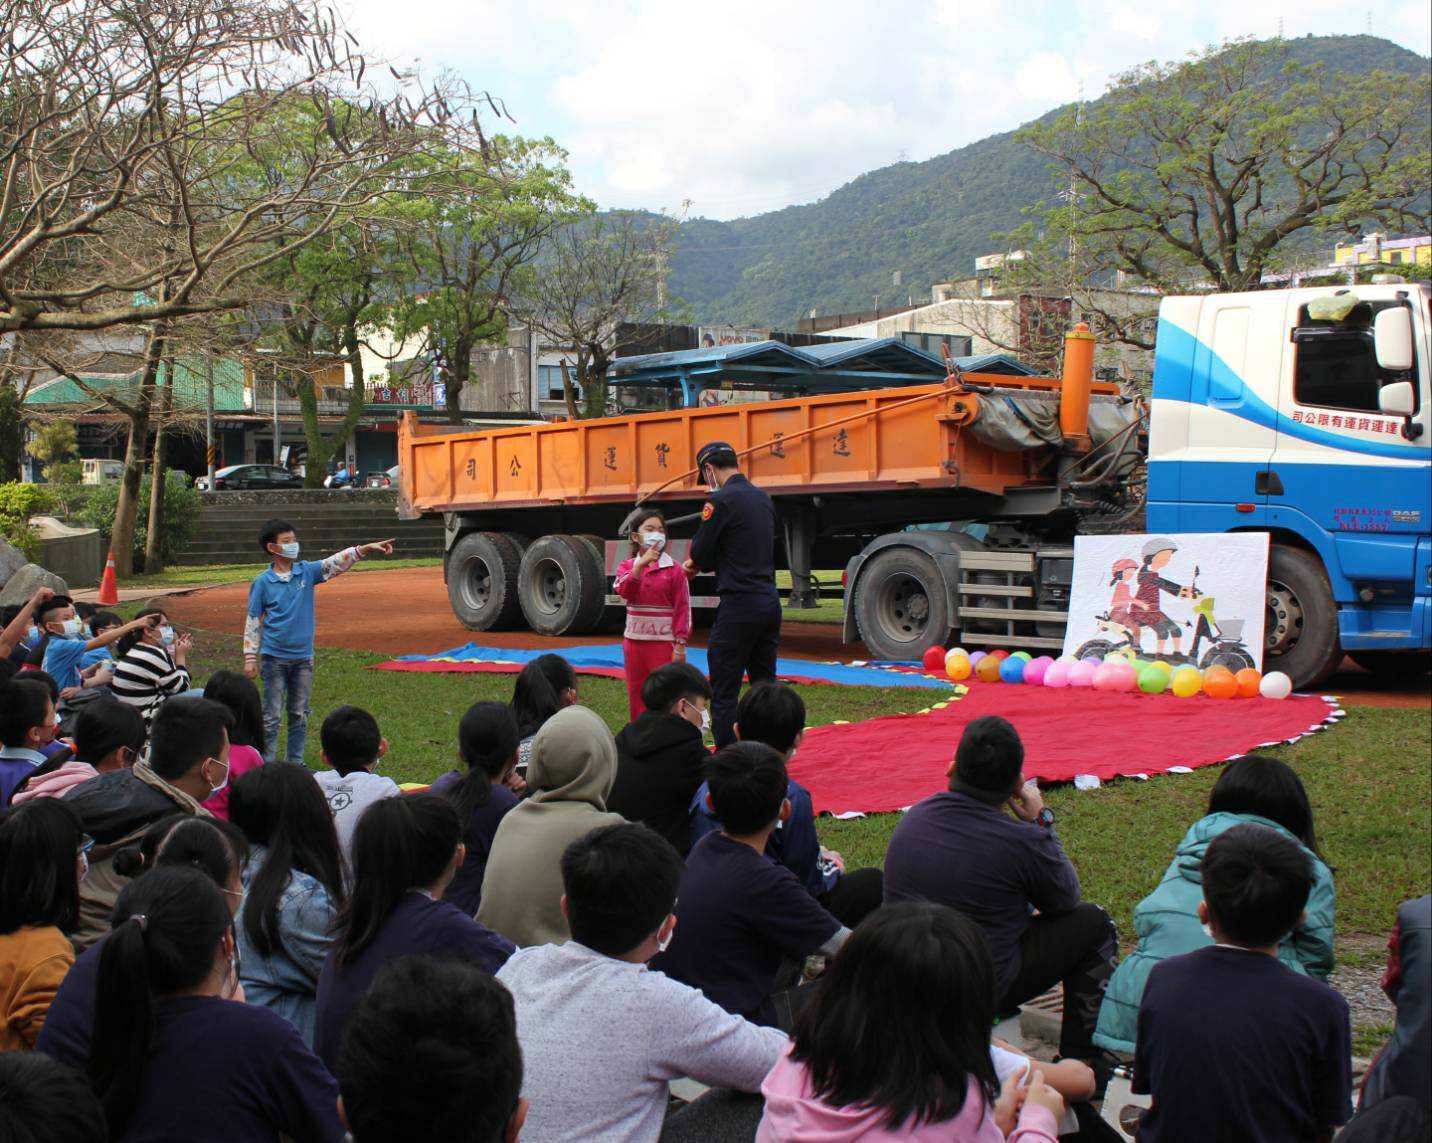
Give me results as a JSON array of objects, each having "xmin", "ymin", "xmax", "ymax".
[{"xmin": 855, "ymin": 547, "xmax": 951, "ymax": 659}]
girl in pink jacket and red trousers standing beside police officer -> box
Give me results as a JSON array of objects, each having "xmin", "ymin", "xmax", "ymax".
[{"xmin": 614, "ymin": 508, "xmax": 692, "ymax": 720}]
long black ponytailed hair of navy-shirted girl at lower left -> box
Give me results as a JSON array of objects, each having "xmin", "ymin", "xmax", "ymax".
[{"xmin": 89, "ymin": 868, "xmax": 233, "ymax": 1139}]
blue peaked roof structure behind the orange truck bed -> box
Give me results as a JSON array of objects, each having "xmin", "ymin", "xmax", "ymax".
[{"xmin": 607, "ymin": 338, "xmax": 1034, "ymax": 407}]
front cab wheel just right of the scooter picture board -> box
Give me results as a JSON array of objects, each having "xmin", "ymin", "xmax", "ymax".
[{"xmin": 1263, "ymin": 544, "xmax": 1342, "ymax": 689}]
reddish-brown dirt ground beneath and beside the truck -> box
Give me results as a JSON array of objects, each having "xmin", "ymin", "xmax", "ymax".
[{"xmin": 165, "ymin": 567, "xmax": 1432, "ymax": 709}]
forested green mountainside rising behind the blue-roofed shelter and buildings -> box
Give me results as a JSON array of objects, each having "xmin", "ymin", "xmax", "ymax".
[{"xmin": 670, "ymin": 36, "xmax": 1428, "ymax": 327}]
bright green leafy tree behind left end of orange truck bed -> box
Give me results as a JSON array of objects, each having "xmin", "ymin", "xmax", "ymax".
[{"xmin": 388, "ymin": 136, "xmax": 591, "ymax": 424}]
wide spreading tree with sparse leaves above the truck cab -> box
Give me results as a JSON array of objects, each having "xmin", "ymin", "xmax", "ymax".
[{"xmin": 1020, "ymin": 40, "xmax": 1432, "ymax": 345}]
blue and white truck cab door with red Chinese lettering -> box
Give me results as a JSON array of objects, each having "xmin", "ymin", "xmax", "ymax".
[{"xmin": 1269, "ymin": 288, "xmax": 1432, "ymax": 607}]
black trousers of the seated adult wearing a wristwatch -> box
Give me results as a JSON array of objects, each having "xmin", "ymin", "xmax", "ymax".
[{"xmin": 1000, "ymin": 901, "xmax": 1118, "ymax": 1061}]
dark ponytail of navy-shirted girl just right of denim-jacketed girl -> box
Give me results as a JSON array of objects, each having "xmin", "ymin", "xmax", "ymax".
[{"xmin": 333, "ymin": 794, "xmax": 463, "ymax": 968}]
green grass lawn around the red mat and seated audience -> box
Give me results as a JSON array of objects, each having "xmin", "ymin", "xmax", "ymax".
[{"xmin": 170, "ymin": 618, "xmax": 1432, "ymax": 963}]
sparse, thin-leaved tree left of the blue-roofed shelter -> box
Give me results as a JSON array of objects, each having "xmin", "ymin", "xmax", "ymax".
[{"xmin": 517, "ymin": 212, "xmax": 676, "ymax": 420}]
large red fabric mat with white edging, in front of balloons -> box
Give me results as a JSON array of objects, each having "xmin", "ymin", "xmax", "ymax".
[{"xmin": 790, "ymin": 683, "xmax": 1337, "ymax": 814}]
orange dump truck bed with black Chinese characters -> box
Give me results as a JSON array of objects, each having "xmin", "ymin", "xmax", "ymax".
[{"xmin": 398, "ymin": 374, "xmax": 1114, "ymax": 514}]
